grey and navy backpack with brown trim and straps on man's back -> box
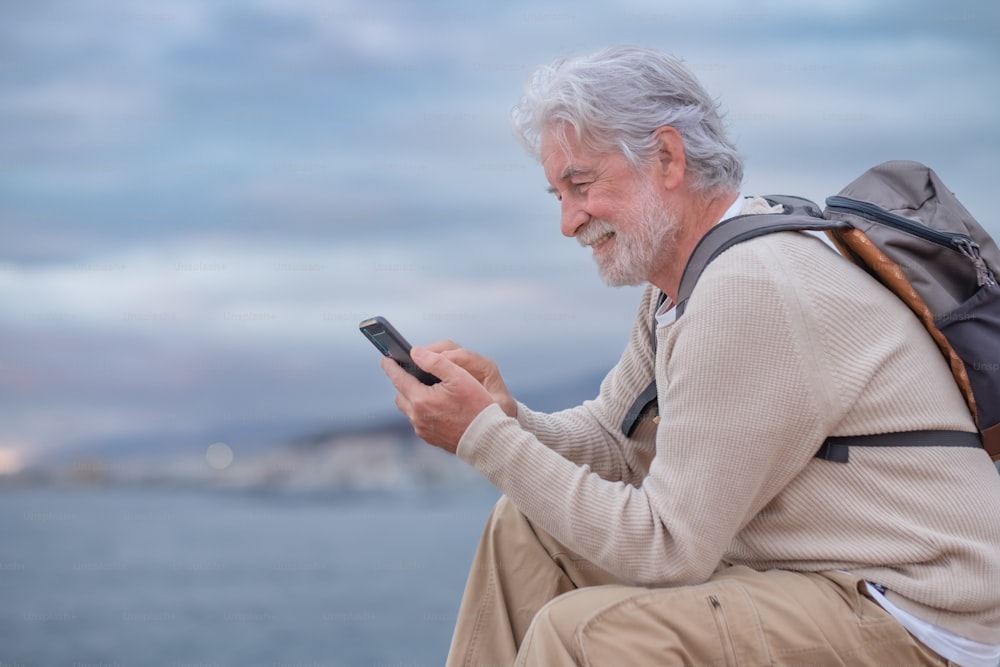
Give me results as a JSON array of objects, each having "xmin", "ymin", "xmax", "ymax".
[{"xmin": 622, "ymin": 161, "xmax": 1000, "ymax": 462}]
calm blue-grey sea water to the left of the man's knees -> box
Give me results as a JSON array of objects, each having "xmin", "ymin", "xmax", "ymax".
[{"xmin": 0, "ymin": 487, "xmax": 498, "ymax": 667}]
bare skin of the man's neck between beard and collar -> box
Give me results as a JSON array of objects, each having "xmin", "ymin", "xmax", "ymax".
[{"xmin": 649, "ymin": 192, "xmax": 738, "ymax": 303}]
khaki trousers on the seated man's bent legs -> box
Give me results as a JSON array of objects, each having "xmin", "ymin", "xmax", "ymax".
[{"xmin": 447, "ymin": 498, "xmax": 950, "ymax": 667}]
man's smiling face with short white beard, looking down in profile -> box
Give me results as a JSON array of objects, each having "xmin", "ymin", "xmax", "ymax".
[{"xmin": 541, "ymin": 127, "xmax": 677, "ymax": 287}]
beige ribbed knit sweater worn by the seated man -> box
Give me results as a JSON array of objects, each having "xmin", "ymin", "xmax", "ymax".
[{"xmin": 457, "ymin": 222, "xmax": 1000, "ymax": 644}]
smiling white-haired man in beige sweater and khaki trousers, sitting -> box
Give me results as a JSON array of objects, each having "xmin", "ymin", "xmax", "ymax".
[{"xmin": 383, "ymin": 47, "xmax": 1000, "ymax": 667}]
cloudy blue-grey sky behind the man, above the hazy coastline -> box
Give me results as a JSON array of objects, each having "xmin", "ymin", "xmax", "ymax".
[{"xmin": 0, "ymin": 0, "xmax": 1000, "ymax": 472}]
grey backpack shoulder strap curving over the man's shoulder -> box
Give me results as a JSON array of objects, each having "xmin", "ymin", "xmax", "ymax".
[{"xmin": 677, "ymin": 195, "xmax": 850, "ymax": 317}]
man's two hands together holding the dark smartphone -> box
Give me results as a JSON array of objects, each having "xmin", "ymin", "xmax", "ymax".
[{"xmin": 382, "ymin": 341, "xmax": 517, "ymax": 454}]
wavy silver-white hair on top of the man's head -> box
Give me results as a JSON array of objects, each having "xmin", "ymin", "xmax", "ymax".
[{"xmin": 511, "ymin": 46, "xmax": 743, "ymax": 192}]
